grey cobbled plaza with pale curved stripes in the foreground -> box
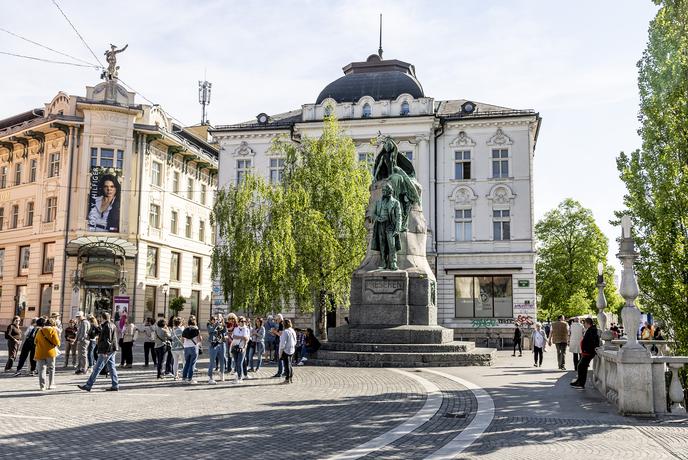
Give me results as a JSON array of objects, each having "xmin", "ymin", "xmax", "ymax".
[{"xmin": 0, "ymin": 346, "xmax": 688, "ymax": 460}]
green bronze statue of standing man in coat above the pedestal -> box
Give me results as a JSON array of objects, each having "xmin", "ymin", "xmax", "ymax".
[{"xmin": 371, "ymin": 183, "xmax": 401, "ymax": 270}]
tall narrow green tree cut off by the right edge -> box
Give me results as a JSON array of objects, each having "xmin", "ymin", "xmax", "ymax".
[{"xmin": 617, "ymin": 0, "xmax": 688, "ymax": 352}]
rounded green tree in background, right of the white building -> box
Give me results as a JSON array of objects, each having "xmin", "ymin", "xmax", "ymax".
[{"xmin": 535, "ymin": 198, "xmax": 615, "ymax": 319}]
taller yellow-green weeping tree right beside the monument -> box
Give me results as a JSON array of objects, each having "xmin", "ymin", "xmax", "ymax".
[{"xmin": 273, "ymin": 118, "xmax": 371, "ymax": 337}]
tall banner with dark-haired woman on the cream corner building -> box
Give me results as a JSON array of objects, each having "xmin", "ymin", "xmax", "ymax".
[{"xmin": 88, "ymin": 166, "xmax": 122, "ymax": 233}]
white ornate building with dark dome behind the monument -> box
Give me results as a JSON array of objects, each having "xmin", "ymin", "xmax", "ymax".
[{"xmin": 212, "ymin": 55, "xmax": 541, "ymax": 339}]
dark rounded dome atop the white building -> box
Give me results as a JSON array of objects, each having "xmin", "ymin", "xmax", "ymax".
[{"xmin": 316, "ymin": 54, "xmax": 425, "ymax": 104}]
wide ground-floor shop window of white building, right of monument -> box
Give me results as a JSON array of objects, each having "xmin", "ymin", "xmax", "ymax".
[{"xmin": 454, "ymin": 275, "xmax": 513, "ymax": 318}]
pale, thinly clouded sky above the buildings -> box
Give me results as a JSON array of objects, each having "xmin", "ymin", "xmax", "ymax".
[{"xmin": 0, "ymin": 0, "xmax": 657, "ymax": 271}]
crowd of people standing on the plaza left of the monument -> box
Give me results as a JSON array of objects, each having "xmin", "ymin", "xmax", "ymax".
[{"xmin": 5, "ymin": 311, "xmax": 320, "ymax": 391}]
